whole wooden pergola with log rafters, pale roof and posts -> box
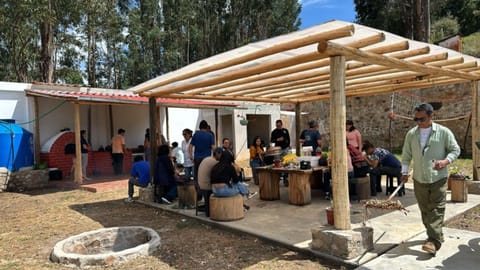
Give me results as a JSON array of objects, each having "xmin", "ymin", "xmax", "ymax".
[{"xmin": 130, "ymin": 21, "xmax": 480, "ymax": 229}]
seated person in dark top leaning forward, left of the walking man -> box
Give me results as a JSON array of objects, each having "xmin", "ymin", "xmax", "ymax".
[{"xmin": 363, "ymin": 141, "xmax": 402, "ymax": 196}]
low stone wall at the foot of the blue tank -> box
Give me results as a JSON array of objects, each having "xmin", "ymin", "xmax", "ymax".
[{"xmin": 0, "ymin": 168, "xmax": 48, "ymax": 192}]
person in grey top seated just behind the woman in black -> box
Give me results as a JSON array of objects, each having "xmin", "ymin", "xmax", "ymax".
[{"xmin": 198, "ymin": 147, "xmax": 223, "ymax": 217}]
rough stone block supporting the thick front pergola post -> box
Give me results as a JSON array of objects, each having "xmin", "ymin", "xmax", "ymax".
[{"xmin": 310, "ymin": 226, "xmax": 373, "ymax": 259}]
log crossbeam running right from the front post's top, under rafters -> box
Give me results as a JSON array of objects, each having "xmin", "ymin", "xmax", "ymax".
[{"xmin": 318, "ymin": 41, "xmax": 480, "ymax": 81}]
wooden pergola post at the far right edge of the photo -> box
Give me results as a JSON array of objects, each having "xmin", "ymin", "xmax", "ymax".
[{"xmin": 472, "ymin": 81, "xmax": 480, "ymax": 180}]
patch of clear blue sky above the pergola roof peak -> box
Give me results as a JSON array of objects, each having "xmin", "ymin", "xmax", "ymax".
[{"xmin": 298, "ymin": 0, "xmax": 355, "ymax": 29}]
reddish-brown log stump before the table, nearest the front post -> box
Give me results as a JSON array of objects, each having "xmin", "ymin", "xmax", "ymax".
[{"xmin": 288, "ymin": 173, "xmax": 312, "ymax": 205}]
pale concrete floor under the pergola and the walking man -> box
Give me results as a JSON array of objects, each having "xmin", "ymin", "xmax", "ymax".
[{"xmin": 137, "ymin": 180, "xmax": 480, "ymax": 269}]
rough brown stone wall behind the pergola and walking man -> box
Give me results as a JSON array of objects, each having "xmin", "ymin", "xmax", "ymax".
[{"xmin": 300, "ymin": 84, "xmax": 472, "ymax": 154}]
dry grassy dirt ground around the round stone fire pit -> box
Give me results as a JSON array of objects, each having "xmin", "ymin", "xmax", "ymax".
[{"xmin": 0, "ymin": 181, "xmax": 480, "ymax": 270}]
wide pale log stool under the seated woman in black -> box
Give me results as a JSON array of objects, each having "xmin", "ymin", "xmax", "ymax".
[{"xmin": 210, "ymin": 194, "xmax": 244, "ymax": 221}]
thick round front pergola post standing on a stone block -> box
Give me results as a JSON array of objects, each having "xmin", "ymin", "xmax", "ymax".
[{"xmin": 330, "ymin": 56, "xmax": 351, "ymax": 230}]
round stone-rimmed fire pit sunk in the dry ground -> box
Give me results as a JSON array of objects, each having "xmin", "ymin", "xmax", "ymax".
[{"xmin": 50, "ymin": 226, "xmax": 160, "ymax": 267}]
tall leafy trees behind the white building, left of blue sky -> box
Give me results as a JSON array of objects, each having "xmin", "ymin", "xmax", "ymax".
[{"xmin": 0, "ymin": 0, "xmax": 301, "ymax": 88}]
